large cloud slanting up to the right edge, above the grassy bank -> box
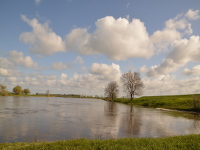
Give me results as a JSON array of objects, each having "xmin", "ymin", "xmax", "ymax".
[{"xmin": 147, "ymin": 36, "xmax": 200, "ymax": 76}]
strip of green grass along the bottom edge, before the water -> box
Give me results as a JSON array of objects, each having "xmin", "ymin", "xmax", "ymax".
[{"xmin": 0, "ymin": 135, "xmax": 200, "ymax": 150}]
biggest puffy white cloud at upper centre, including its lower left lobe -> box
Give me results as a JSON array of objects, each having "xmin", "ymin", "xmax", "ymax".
[{"xmin": 66, "ymin": 16, "xmax": 153, "ymax": 60}]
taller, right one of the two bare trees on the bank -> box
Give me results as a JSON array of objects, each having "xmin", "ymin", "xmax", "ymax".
[{"xmin": 121, "ymin": 71, "xmax": 144, "ymax": 101}]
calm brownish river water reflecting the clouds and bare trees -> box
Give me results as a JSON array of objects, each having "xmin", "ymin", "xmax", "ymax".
[{"xmin": 0, "ymin": 96, "xmax": 200, "ymax": 143}]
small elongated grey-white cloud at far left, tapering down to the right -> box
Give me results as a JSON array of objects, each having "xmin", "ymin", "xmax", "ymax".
[{"xmin": 8, "ymin": 50, "xmax": 41, "ymax": 70}]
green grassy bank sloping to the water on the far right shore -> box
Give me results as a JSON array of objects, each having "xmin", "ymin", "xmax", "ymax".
[{"xmin": 114, "ymin": 95, "xmax": 200, "ymax": 112}]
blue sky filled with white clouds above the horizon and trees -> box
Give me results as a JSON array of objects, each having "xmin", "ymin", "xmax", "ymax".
[{"xmin": 0, "ymin": 0, "xmax": 200, "ymax": 97}]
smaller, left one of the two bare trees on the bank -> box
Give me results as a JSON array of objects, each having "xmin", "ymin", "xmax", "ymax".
[{"xmin": 105, "ymin": 81, "xmax": 119, "ymax": 101}]
